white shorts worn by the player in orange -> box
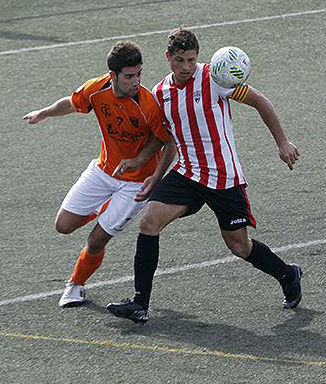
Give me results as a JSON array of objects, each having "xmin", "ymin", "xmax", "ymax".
[{"xmin": 61, "ymin": 160, "xmax": 146, "ymax": 236}]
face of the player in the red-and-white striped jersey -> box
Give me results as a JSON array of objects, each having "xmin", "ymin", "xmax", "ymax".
[{"xmin": 166, "ymin": 49, "xmax": 198, "ymax": 85}]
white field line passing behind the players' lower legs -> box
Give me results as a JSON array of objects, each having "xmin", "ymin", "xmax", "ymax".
[{"xmin": 0, "ymin": 240, "xmax": 326, "ymax": 306}]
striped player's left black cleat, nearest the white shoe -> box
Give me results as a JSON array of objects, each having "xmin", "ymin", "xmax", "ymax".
[{"xmin": 106, "ymin": 299, "xmax": 149, "ymax": 324}]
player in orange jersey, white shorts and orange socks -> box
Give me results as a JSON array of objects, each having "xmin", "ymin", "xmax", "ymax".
[{"xmin": 23, "ymin": 41, "xmax": 175, "ymax": 307}]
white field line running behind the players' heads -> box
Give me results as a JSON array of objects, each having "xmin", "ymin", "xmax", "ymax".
[{"xmin": 0, "ymin": 8, "xmax": 326, "ymax": 56}]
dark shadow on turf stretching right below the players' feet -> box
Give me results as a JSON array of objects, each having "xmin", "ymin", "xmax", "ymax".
[{"xmin": 115, "ymin": 308, "xmax": 326, "ymax": 358}]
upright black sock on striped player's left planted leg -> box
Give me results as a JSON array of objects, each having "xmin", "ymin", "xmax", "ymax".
[{"xmin": 134, "ymin": 233, "xmax": 159, "ymax": 309}]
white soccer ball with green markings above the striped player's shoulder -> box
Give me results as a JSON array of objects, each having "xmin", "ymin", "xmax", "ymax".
[{"xmin": 210, "ymin": 47, "xmax": 251, "ymax": 88}]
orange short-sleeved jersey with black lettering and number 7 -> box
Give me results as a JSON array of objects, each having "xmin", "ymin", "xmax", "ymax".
[{"xmin": 72, "ymin": 74, "xmax": 170, "ymax": 182}]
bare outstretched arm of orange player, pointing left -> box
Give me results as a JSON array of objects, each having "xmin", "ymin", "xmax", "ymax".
[{"xmin": 23, "ymin": 96, "xmax": 75, "ymax": 124}]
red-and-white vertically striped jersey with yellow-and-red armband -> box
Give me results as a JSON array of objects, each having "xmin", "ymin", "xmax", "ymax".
[{"xmin": 153, "ymin": 64, "xmax": 249, "ymax": 189}]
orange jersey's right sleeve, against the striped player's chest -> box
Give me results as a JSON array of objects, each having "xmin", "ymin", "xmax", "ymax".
[{"xmin": 146, "ymin": 91, "xmax": 171, "ymax": 143}]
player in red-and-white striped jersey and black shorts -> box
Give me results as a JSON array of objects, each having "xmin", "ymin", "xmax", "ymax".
[{"xmin": 107, "ymin": 28, "xmax": 302, "ymax": 322}]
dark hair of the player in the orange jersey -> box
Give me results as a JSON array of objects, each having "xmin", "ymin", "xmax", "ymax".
[{"xmin": 107, "ymin": 41, "xmax": 143, "ymax": 76}]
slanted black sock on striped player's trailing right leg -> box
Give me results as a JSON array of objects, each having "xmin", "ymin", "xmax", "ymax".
[{"xmin": 246, "ymin": 239, "xmax": 295, "ymax": 284}]
